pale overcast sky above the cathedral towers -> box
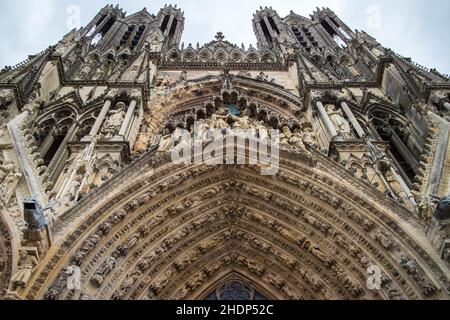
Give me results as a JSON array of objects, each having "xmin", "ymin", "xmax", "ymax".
[{"xmin": 0, "ymin": 0, "xmax": 450, "ymax": 74}]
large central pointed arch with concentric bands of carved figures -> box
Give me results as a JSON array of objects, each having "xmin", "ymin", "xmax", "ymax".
[{"xmin": 23, "ymin": 145, "xmax": 449, "ymax": 299}]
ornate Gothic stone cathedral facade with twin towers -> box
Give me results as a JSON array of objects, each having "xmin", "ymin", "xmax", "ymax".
[{"xmin": 0, "ymin": 5, "xmax": 450, "ymax": 300}]
